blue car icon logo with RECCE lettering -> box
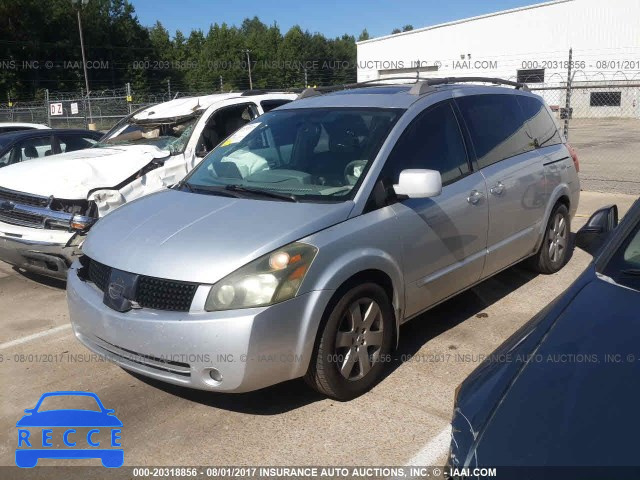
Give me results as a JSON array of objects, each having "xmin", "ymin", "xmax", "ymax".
[{"xmin": 16, "ymin": 391, "xmax": 124, "ymax": 468}]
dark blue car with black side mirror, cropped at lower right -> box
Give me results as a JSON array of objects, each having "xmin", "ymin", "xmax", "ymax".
[{"xmin": 449, "ymin": 200, "xmax": 640, "ymax": 479}]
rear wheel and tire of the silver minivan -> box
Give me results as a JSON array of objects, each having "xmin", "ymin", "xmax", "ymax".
[{"xmin": 527, "ymin": 203, "xmax": 571, "ymax": 274}]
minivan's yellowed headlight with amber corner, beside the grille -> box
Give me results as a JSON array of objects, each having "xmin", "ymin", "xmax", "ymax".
[{"xmin": 204, "ymin": 242, "xmax": 318, "ymax": 312}]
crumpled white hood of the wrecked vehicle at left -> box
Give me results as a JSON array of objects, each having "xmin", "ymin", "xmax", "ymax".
[{"xmin": 0, "ymin": 145, "xmax": 169, "ymax": 200}]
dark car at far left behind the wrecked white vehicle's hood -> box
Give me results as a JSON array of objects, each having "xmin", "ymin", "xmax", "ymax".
[{"xmin": 0, "ymin": 128, "xmax": 104, "ymax": 168}]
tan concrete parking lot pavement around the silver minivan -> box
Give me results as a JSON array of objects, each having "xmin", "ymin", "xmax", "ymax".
[{"xmin": 0, "ymin": 191, "xmax": 636, "ymax": 466}]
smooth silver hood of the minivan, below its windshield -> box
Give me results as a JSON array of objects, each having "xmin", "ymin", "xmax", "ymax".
[{"xmin": 82, "ymin": 190, "xmax": 353, "ymax": 284}]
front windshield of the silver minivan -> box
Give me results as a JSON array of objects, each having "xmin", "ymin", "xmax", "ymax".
[{"xmin": 183, "ymin": 108, "xmax": 402, "ymax": 201}]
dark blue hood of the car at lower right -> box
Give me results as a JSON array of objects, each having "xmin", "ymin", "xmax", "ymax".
[{"xmin": 460, "ymin": 275, "xmax": 640, "ymax": 466}]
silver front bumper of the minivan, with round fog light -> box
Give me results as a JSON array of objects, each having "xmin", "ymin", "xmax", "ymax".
[{"xmin": 67, "ymin": 263, "xmax": 334, "ymax": 392}]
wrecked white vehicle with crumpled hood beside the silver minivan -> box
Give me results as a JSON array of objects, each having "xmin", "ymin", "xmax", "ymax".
[{"xmin": 0, "ymin": 92, "xmax": 296, "ymax": 279}]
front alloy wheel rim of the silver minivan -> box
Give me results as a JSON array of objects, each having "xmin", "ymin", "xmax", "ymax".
[{"xmin": 335, "ymin": 298, "xmax": 384, "ymax": 380}]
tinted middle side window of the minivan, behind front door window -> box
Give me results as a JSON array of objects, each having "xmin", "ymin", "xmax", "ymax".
[{"xmin": 456, "ymin": 94, "xmax": 534, "ymax": 168}]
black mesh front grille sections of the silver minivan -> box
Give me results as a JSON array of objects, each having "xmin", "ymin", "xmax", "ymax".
[{"xmin": 81, "ymin": 256, "xmax": 198, "ymax": 312}]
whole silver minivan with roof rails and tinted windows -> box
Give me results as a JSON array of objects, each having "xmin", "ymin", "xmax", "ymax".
[{"xmin": 67, "ymin": 81, "xmax": 580, "ymax": 400}]
